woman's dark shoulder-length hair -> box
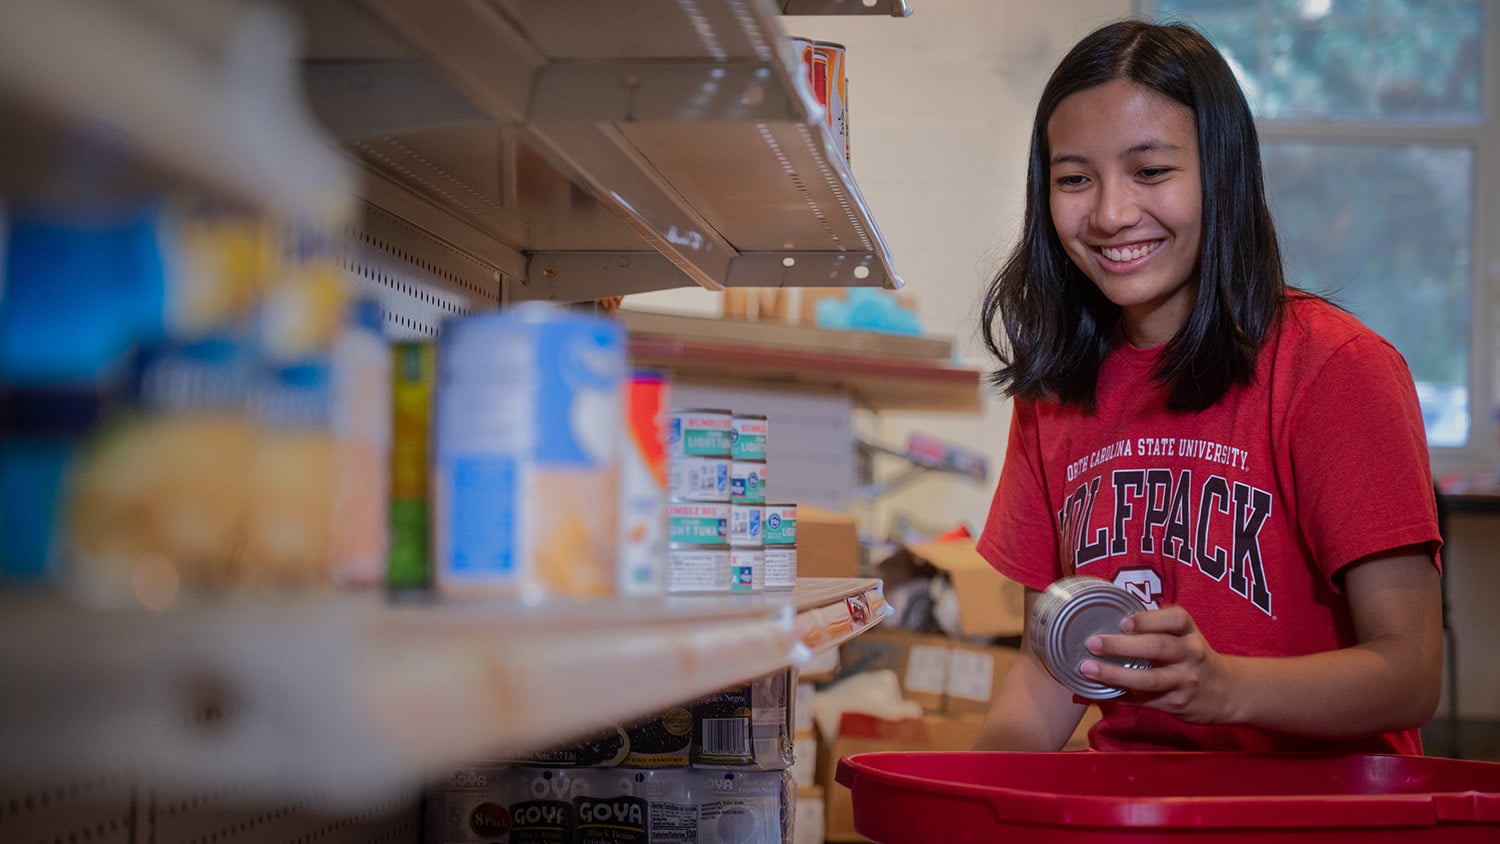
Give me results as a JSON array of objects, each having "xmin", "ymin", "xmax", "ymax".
[{"xmin": 981, "ymin": 19, "xmax": 1287, "ymax": 411}]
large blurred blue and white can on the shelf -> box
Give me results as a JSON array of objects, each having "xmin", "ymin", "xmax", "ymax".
[{"xmin": 432, "ymin": 303, "xmax": 626, "ymax": 600}]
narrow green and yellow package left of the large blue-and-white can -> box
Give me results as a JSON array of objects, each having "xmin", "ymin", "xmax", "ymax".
[{"xmin": 386, "ymin": 342, "xmax": 437, "ymax": 595}]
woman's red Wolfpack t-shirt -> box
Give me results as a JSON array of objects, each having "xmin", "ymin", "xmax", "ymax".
[{"xmin": 978, "ymin": 295, "xmax": 1440, "ymax": 754}]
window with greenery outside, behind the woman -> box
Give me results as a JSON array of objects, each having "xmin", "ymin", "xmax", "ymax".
[{"xmin": 1143, "ymin": 0, "xmax": 1500, "ymax": 469}]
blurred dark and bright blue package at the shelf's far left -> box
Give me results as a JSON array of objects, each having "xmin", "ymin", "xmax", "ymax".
[{"xmin": 0, "ymin": 202, "xmax": 167, "ymax": 583}]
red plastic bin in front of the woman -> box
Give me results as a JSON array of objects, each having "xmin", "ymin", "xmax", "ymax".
[{"xmin": 837, "ymin": 751, "xmax": 1500, "ymax": 844}]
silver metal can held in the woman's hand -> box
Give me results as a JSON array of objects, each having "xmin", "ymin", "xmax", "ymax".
[{"xmin": 1031, "ymin": 577, "xmax": 1151, "ymax": 700}]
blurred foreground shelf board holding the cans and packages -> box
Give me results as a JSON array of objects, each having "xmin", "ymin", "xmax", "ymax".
[{"xmin": 0, "ymin": 579, "xmax": 891, "ymax": 807}]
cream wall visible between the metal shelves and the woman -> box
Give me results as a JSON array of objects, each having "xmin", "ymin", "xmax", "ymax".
[{"xmin": 626, "ymin": 0, "xmax": 1134, "ymax": 532}]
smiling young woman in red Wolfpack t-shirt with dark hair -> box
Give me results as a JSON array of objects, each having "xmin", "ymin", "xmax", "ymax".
[{"xmin": 977, "ymin": 21, "xmax": 1442, "ymax": 753}]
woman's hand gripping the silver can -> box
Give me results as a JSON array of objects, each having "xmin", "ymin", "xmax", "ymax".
[{"xmin": 1080, "ymin": 606, "xmax": 1233, "ymax": 724}]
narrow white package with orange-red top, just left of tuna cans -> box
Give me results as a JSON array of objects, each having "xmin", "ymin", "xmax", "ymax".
[{"xmin": 620, "ymin": 369, "xmax": 669, "ymax": 595}]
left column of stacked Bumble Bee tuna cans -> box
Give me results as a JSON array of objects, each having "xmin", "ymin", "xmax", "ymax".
[{"xmin": 666, "ymin": 408, "xmax": 734, "ymax": 592}]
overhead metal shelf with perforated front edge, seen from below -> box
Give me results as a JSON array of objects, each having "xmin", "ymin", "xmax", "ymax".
[{"xmin": 299, "ymin": 0, "xmax": 903, "ymax": 301}]
